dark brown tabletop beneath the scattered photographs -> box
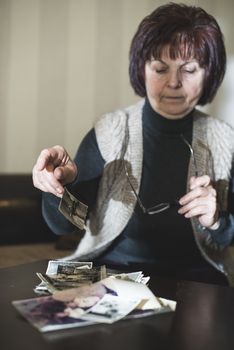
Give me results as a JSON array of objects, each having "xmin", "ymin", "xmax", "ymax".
[{"xmin": 0, "ymin": 261, "xmax": 234, "ymax": 350}]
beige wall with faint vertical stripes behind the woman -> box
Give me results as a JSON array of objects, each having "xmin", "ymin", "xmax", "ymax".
[{"xmin": 0, "ymin": 0, "xmax": 234, "ymax": 173}]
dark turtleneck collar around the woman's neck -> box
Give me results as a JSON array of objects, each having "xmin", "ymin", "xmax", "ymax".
[{"xmin": 143, "ymin": 98, "xmax": 193, "ymax": 136}]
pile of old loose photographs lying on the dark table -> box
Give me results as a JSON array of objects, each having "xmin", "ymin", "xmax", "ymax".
[{"xmin": 12, "ymin": 261, "xmax": 176, "ymax": 332}]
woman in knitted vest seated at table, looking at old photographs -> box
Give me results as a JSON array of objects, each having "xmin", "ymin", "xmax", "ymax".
[{"xmin": 33, "ymin": 3, "xmax": 234, "ymax": 283}]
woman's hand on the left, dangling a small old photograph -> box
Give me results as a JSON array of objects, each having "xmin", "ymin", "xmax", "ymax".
[{"xmin": 32, "ymin": 146, "xmax": 77, "ymax": 197}]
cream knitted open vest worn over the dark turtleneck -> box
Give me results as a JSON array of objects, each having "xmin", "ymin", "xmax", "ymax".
[{"xmin": 65, "ymin": 101, "xmax": 234, "ymax": 280}]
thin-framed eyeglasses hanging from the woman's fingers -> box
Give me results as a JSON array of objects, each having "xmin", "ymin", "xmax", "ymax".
[{"xmin": 123, "ymin": 135, "xmax": 198, "ymax": 215}]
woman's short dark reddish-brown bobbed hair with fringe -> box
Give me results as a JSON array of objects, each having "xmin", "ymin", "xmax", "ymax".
[{"xmin": 129, "ymin": 2, "xmax": 226, "ymax": 105}]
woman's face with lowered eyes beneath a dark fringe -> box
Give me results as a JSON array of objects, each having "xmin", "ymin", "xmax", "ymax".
[{"xmin": 145, "ymin": 49, "xmax": 205, "ymax": 119}]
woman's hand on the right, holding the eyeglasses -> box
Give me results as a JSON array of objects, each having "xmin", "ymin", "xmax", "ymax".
[{"xmin": 178, "ymin": 175, "xmax": 219, "ymax": 229}]
